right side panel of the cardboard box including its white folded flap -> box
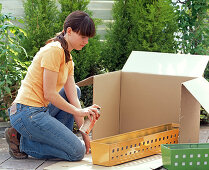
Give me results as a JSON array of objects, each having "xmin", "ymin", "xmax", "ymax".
[{"xmin": 180, "ymin": 77, "xmax": 209, "ymax": 143}]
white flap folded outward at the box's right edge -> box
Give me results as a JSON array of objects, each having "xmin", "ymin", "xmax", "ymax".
[{"xmin": 183, "ymin": 77, "xmax": 209, "ymax": 113}]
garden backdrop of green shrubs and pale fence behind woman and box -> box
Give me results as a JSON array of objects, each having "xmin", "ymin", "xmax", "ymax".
[{"xmin": 0, "ymin": 0, "xmax": 209, "ymax": 123}]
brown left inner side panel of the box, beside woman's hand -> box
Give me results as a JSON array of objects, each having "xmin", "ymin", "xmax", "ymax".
[{"xmin": 92, "ymin": 71, "xmax": 121, "ymax": 139}]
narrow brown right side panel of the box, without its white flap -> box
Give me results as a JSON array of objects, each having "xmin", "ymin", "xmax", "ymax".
[{"xmin": 179, "ymin": 86, "xmax": 200, "ymax": 143}]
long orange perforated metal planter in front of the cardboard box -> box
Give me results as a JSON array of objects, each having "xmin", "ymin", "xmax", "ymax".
[{"xmin": 91, "ymin": 123, "xmax": 179, "ymax": 166}]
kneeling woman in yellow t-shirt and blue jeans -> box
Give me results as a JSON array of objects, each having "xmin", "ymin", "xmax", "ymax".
[{"xmin": 5, "ymin": 11, "xmax": 99, "ymax": 161}]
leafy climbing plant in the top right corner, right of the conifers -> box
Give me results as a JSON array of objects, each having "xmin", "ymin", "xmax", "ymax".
[{"xmin": 175, "ymin": 0, "xmax": 209, "ymax": 55}]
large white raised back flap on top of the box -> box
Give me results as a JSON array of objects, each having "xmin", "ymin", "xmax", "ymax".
[{"xmin": 122, "ymin": 51, "xmax": 209, "ymax": 77}]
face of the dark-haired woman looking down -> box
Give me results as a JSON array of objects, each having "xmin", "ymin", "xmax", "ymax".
[{"xmin": 68, "ymin": 30, "xmax": 89, "ymax": 50}]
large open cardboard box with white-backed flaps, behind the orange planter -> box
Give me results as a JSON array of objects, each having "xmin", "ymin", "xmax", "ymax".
[{"xmin": 77, "ymin": 51, "xmax": 209, "ymax": 143}]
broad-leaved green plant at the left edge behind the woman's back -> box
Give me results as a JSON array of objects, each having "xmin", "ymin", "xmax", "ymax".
[{"xmin": 0, "ymin": 11, "xmax": 30, "ymax": 120}]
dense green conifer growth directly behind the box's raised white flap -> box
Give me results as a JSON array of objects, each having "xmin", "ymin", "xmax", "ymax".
[{"xmin": 102, "ymin": 0, "xmax": 178, "ymax": 71}]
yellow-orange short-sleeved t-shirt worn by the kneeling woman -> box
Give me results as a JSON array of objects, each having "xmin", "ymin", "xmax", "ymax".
[{"xmin": 13, "ymin": 41, "xmax": 74, "ymax": 107}]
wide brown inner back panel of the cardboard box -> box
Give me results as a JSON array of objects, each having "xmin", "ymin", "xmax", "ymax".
[{"xmin": 120, "ymin": 72, "xmax": 191, "ymax": 133}]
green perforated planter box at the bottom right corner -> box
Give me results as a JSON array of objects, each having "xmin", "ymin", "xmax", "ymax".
[{"xmin": 161, "ymin": 143, "xmax": 209, "ymax": 170}]
